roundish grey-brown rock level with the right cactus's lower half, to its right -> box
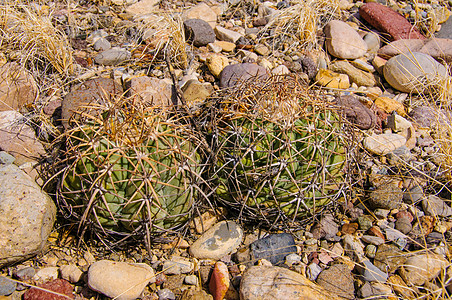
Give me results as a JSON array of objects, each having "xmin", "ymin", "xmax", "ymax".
[{"xmin": 369, "ymin": 185, "xmax": 403, "ymax": 209}]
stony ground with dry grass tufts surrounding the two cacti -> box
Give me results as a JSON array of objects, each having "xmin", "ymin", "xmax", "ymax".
[{"xmin": 0, "ymin": 0, "xmax": 452, "ymax": 300}]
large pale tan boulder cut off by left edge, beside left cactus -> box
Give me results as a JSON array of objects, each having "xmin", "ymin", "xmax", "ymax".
[{"xmin": 0, "ymin": 165, "xmax": 56, "ymax": 267}]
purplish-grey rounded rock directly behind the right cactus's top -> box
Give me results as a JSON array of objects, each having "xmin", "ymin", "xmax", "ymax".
[{"xmin": 220, "ymin": 63, "xmax": 268, "ymax": 88}]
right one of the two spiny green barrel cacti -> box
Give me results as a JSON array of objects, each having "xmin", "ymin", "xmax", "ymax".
[{"xmin": 207, "ymin": 77, "xmax": 347, "ymax": 224}]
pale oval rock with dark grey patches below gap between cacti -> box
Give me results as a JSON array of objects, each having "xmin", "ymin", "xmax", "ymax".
[{"xmin": 190, "ymin": 221, "xmax": 243, "ymax": 260}]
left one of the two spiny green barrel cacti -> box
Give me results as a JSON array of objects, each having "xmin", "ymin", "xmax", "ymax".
[{"xmin": 58, "ymin": 101, "xmax": 205, "ymax": 244}]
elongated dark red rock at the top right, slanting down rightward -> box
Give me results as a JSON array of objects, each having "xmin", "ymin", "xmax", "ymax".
[{"xmin": 359, "ymin": 2, "xmax": 425, "ymax": 40}]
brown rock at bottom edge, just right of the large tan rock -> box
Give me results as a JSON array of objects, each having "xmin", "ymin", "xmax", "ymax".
[{"xmin": 317, "ymin": 264, "xmax": 355, "ymax": 299}]
